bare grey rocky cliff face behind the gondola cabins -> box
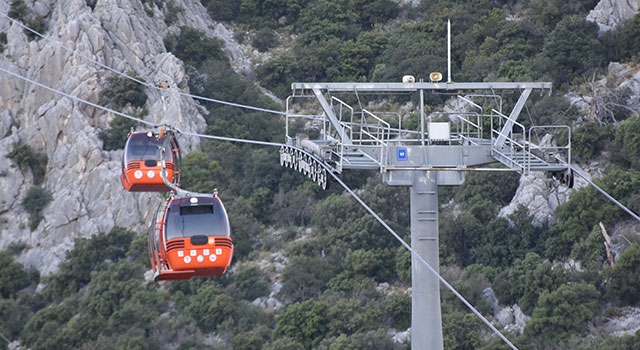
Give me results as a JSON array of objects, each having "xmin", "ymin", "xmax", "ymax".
[{"xmin": 0, "ymin": 0, "xmax": 222, "ymax": 274}]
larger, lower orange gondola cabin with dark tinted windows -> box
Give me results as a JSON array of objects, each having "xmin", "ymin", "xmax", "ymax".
[{"xmin": 149, "ymin": 193, "xmax": 233, "ymax": 281}]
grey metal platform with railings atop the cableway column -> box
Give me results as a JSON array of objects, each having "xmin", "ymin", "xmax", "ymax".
[{"xmin": 286, "ymin": 83, "xmax": 571, "ymax": 182}]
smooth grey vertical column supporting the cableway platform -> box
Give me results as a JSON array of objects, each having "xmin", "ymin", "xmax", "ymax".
[{"xmin": 410, "ymin": 171, "xmax": 444, "ymax": 350}]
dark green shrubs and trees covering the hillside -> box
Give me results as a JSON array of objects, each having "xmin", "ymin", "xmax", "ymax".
[{"xmin": 0, "ymin": 0, "xmax": 640, "ymax": 350}]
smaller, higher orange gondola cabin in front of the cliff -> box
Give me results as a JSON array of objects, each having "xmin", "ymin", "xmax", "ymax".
[{"xmin": 120, "ymin": 129, "xmax": 182, "ymax": 192}]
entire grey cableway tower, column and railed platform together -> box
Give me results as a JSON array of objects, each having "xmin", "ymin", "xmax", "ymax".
[{"xmin": 280, "ymin": 78, "xmax": 573, "ymax": 349}]
